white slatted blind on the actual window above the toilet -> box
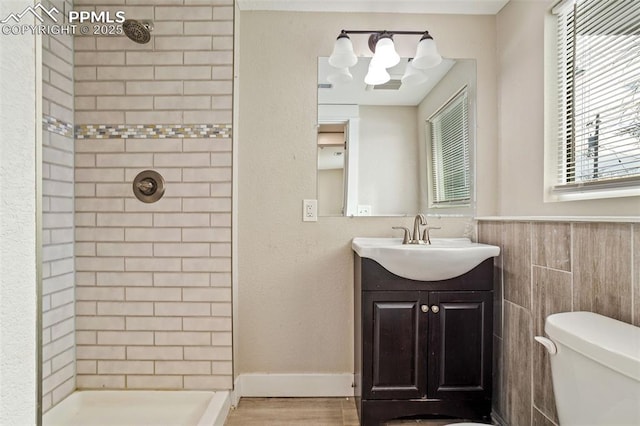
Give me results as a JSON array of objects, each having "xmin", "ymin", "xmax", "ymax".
[{"xmin": 554, "ymin": 0, "xmax": 640, "ymax": 191}]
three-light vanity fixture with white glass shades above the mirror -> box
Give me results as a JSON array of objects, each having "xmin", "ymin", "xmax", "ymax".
[{"xmin": 329, "ymin": 30, "xmax": 442, "ymax": 85}]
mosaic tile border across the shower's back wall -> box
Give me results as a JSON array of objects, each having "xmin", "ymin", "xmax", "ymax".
[{"xmin": 75, "ymin": 124, "xmax": 232, "ymax": 139}]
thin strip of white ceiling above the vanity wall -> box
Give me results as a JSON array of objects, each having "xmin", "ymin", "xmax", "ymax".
[{"xmin": 237, "ymin": 0, "xmax": 509, "ymax": 15}]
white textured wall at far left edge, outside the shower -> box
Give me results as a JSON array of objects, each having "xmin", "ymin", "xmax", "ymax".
[{"xmin": 0, "ymin": 0, "xmax": 42, "ymax": 425}]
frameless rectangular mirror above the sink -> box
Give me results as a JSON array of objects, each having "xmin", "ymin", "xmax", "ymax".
[{"xmin": 317, "ymin": 57, "xmax": 476, "ymax": 216}]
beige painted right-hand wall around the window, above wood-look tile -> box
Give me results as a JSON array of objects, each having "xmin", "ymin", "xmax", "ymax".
[{"xmin": 498, "ymin": 1, "xmax": 640, "ymax": 216}]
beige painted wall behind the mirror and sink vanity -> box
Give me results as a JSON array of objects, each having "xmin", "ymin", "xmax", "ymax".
[{"xmin": 234, "ymin": 12, "xmax": 497, "ymax": 374}]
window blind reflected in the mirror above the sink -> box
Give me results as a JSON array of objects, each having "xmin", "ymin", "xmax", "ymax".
[{"xmin": 428, "ymin": 87, "xmax": 471, "ymax": 207}]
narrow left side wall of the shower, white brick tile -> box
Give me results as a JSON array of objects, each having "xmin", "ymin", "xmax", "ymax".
[{"xmin": 42, "ymin": 1, "xmax": 75, "ymax": 412}]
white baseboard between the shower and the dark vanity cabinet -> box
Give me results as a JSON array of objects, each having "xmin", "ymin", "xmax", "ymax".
[{"xmin": 233, "ymin": 373, "xmax": 353, "ymax": 405}]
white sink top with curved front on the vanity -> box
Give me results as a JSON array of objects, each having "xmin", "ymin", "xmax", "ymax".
[{"xmin": 351, "ymin": 237, "xmax": 500, "ymax": 281}]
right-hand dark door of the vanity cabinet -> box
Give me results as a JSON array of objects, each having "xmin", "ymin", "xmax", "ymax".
[{"xmin": 427, "ymin": 291, "xmax": 493, "ymax": 399}]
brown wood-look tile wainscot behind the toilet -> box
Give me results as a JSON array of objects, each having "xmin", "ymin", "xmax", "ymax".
[{"xmin": 478, "ymin": 221, "xmax": 640, "ymax": 426}]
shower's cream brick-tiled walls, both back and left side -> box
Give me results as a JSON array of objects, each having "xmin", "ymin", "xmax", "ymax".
[{"xmin": 42, "ymin": 0, "xmax": 234, "ymax": 411}]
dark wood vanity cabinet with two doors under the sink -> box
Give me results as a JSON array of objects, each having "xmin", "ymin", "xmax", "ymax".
[{"xmin": 355, "ymin": 255, "xmax": 493, "ymax": 426}]
